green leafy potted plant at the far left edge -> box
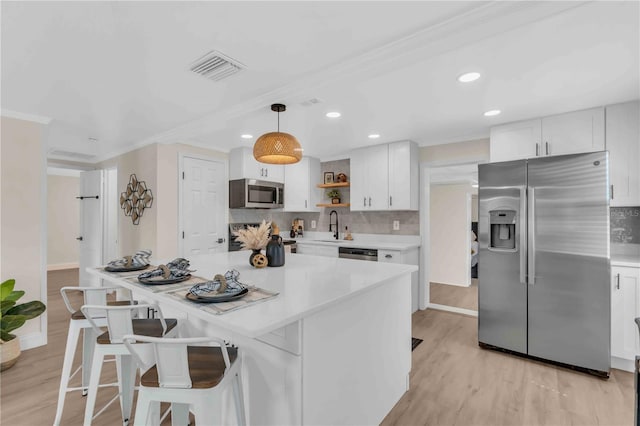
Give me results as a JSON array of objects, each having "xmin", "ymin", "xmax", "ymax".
[{"xmin": 0, "ymin": 279, "xmax": 47, "ymax": 371}]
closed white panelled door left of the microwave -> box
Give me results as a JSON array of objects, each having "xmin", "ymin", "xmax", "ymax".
[{"xmin": 181, "ymin": 157, "xmax": 228, "ymax": 258}]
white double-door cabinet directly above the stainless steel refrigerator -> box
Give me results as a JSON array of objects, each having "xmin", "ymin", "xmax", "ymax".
[{"xmin": 490, "ymin": 108, "xmax": 604, "ymax": 162}]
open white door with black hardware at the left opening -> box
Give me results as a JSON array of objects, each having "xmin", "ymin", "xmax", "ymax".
[{"xmin": 78, "ymin": 170, "xmax": 104, "ymax": 287}]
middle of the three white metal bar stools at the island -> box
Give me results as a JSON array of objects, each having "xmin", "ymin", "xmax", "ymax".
[{"xmin": 81, "ymin": 304, "xmax": 178, "ymax": 426}]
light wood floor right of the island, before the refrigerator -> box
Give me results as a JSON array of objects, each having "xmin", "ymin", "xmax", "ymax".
[{"xmin": 382, "ymin": 310, "xmax": 634, "ymax": 426}]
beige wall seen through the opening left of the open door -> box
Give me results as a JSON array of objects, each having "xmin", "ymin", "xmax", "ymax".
[{"xmin": 47, "ymin": 175, "xmax": 80, "ymax": 268}]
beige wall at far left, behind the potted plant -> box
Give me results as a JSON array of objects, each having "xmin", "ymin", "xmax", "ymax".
[{"xmin": 0, "ymin": 117, "xmax": 46, "ymax": 342}]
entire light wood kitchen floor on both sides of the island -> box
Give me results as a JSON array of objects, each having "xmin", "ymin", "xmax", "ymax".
[{"xmin": 0, "ymin": 270, "xmax": 634, "ymax": 426}]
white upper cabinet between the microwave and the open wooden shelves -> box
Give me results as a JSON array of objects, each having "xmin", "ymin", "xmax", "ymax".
[{"xmin": 284, "ymin": 157, "xmax": 322, "ymax": 212}]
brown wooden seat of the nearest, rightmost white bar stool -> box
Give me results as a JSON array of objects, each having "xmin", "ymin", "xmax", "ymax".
[{"xmin": 140, "ymin": 346, "xmax": 238, "ymax": 389}]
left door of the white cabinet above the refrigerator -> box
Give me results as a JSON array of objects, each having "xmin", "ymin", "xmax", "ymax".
[{"xmin": 489, "ymin": 119, "xmax": 542, "ymax": 163}]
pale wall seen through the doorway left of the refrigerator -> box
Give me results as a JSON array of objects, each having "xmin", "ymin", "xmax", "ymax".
[{"xmin": 429, "ymin": 184, "xmax": 472, "ymax": 285}]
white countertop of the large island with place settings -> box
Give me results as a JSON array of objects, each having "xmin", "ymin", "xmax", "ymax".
[{"xmin": 89, "ymin": 251, "xmax": 418, "ymax": 338}]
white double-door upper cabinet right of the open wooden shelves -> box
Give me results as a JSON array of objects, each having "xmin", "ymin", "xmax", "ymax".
[{"xmin": 351, "ymin": 141, "xmax": 419, "ymax": 211}]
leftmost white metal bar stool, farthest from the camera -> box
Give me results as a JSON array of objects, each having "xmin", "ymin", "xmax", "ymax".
[{"xmin": 53, "ymin": 287, "xmax": 136, "ymax": 425}]
